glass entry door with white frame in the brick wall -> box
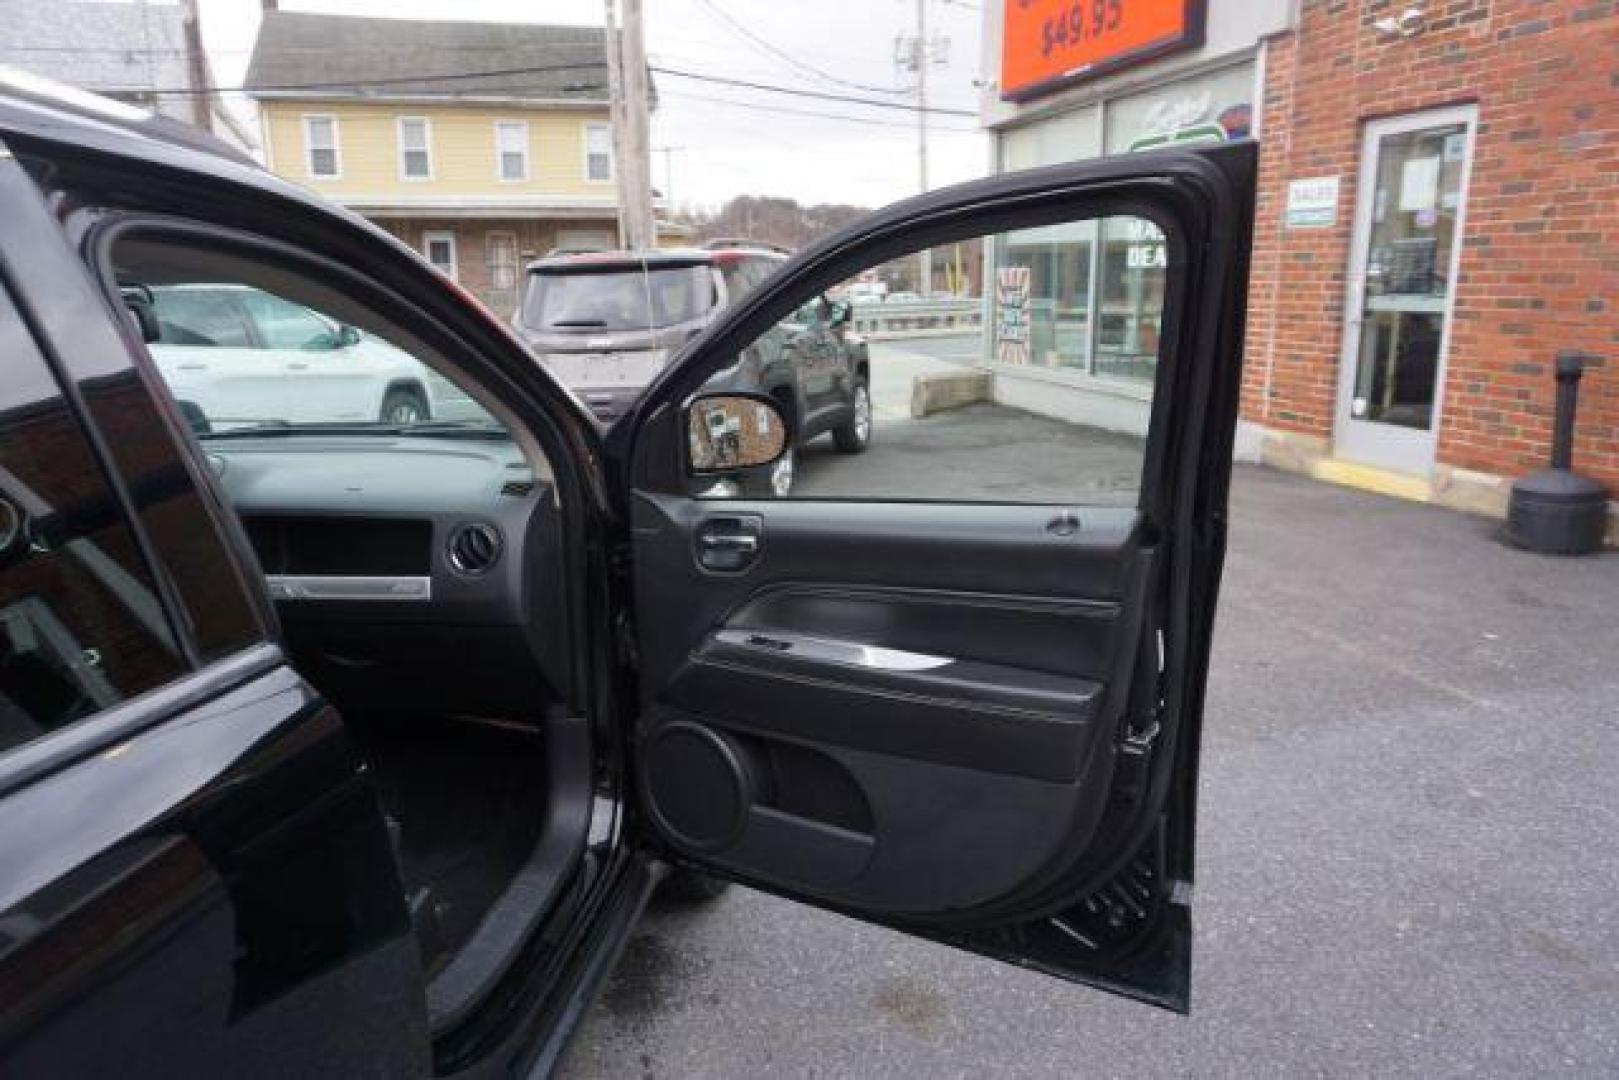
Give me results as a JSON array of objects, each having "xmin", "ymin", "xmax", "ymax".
[{"xmin": 1334, "ymin": 107, "xmax": 1475, "ymax": 473}]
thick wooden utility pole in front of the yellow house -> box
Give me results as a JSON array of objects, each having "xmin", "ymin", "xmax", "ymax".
[{"xmin": 606, "ymin": 0, "xmax": 657, "ymax": 249}]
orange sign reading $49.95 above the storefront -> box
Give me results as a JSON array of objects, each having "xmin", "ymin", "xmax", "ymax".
[{"xmin": 1001, "ymin": 0, "xmax": 1203, "ymax": 100}]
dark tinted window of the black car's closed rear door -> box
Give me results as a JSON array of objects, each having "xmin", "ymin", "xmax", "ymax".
[{"xmin": 0, "ymin": 283, "xmax": 185, "ymax": 753}]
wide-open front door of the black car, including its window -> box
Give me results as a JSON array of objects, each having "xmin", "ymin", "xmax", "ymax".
[{"xmin": 609, "ymin": 142, "xmax": 1256, "ymax": 1010}]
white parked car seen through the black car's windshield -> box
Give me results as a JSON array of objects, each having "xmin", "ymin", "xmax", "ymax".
[{"xmin": 135, "ymin": 285, "xmax": 453, "ymax": 427}]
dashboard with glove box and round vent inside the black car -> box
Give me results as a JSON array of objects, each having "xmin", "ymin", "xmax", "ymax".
[{"xmin": 204, "ymin": 432, "xmax": 570, "ymax": 714}]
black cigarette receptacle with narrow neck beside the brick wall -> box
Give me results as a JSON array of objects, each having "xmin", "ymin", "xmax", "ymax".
[{"xmin": 1506, "ymin": 351, "xmax": 1608, "ymax": 555}]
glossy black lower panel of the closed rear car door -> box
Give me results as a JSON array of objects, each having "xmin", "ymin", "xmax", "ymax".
[{"xmin": 0, "ymin": 660, "xmax": 426, "ymax": 1077}]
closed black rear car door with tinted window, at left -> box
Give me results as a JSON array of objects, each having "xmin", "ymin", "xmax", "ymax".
[{"xmin": 0, "ymin": 135, "xmax": 431, "ymax": 1077}]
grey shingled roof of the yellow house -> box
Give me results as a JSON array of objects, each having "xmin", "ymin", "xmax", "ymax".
[{"xmin": 246, "ymin": 11, "xmax": 607, "ymax": 102}]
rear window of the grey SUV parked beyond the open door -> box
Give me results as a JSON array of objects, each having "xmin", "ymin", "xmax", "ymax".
[{"xmin": 523, "ymin": 266, "xmax": 714, "ymax": 330}]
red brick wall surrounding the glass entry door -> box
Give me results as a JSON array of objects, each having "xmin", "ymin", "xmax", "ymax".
[{"xmin": 1242, "ymin": 0, "xmax": 1619, "ymax": 491}]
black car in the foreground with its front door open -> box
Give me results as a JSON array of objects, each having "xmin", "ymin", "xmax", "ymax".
[{"xmin": 0, "ymin": 76, "xmax": 1256, "ymax": 1077}]
